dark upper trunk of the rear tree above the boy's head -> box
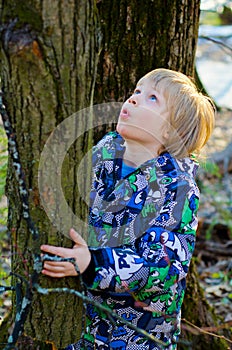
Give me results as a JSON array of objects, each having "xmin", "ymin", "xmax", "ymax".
[{"xmin": 94, "ymin": 0, "xmax": 200, "ymax": 142}]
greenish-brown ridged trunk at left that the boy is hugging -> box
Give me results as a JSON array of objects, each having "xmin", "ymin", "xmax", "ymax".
[{"xmin": 1, "ymin": 0, "xmax": 99, "ymax": 350}]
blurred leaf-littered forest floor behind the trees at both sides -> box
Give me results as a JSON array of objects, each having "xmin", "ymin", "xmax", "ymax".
[{"xmin": 0, "ymin": 109, "xmax": 232, "ymax": 336}]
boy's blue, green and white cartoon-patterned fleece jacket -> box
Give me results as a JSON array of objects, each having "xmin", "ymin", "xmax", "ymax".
[{"xmin": 67, "ymin": 132, "xmax": 199, "ymax": 350}]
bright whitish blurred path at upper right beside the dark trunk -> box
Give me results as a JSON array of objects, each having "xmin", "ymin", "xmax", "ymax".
[{"xmin": 196, "ymin": 25, "xmax": 232, "ymax": 110}]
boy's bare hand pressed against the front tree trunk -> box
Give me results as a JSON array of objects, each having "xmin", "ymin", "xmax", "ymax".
[{"xmin": 41, "ymin": 229, "xmax": 91, "ymax": 278}]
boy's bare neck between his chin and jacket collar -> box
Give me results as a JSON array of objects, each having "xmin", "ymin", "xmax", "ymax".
[{"xmin": 123, "ymin": 140, "xmax": 158, "ymax": 167}]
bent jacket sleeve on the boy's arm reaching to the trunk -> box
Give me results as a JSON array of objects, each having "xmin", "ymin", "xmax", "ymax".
[{"xmin": 83, "ymin": 178, "xmax": 199, "ymax": 293}]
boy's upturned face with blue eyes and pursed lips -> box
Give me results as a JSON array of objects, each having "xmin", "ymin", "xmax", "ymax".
[{"xmin": 117, "ymin": 79, "xmax": 169, "ymax": 153}]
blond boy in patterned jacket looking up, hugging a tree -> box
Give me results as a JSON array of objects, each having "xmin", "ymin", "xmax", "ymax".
[{"xmin": 41, "ymin": 69, "xmax": 214, "ymax": 350}]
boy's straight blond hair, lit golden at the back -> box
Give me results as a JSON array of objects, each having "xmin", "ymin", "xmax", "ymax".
[{"xmin": 138, "ymin": 68, "xmax": 216, "ymax": 158}]
